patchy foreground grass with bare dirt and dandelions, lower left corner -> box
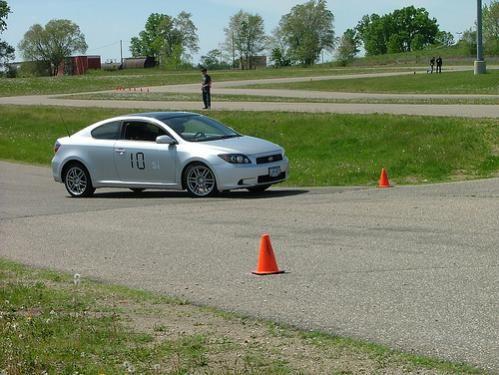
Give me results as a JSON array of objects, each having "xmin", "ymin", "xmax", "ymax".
[{"xmin": 0, "ymin": 259, "xmax": 484, "ymax": 374}]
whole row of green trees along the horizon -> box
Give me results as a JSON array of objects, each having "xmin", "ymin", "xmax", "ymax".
[{"xmin": 0, "ymin": 0, "xmax": 499, "ymax": 75}]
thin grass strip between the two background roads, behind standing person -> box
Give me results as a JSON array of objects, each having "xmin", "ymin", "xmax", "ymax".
[{"xmin": 62, "ymin": 92, "xmax": 499, "ymax": 105}]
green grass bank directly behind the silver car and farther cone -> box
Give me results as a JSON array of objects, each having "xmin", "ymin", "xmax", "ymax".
[{"xmin": 0, "ymin": 107, "xmax": 499, "ymax": 186}]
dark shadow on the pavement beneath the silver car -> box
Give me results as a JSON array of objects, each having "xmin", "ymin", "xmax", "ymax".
[{"xmin": 89, "ymin": 189, "xmax": 309, "ymax": 199}]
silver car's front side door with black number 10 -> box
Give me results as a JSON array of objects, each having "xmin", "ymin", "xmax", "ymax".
[{"xmin": 114, "ymin": 120, "xmax": 177, "ymax": 186}]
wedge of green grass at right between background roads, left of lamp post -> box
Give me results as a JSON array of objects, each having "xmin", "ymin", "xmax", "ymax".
[{"xmin": 241, "ymin": 70, "xmax": 499, "ymax": 95}]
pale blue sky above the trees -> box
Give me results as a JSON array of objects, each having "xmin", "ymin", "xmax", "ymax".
[{"xmin": 1, "ymin": 0, "xmax": 489, "ymax": 61}]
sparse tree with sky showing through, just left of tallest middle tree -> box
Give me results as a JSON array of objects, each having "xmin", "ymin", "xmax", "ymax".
[{"xmin": 224, "ymin": 10, "xmax": 267, "ymax": 69}]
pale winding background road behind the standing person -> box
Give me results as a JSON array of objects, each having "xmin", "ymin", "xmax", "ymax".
[{"xmin": 0, "ymin": 67, "xmax": 499, "ymax": 118}]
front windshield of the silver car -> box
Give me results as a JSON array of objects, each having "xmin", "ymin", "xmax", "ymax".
[{"xmin": 164, "ymin": 115, "xmax": 241, "ymax": 142}]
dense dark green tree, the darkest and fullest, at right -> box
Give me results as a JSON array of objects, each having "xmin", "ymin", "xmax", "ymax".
[{"xmin": 356, "ymin": 6, "xmax": 439, "ymax": 55}]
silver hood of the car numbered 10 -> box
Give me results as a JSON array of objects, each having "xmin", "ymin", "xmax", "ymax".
[{"xmin": 194, "ymin": 136, "xmax": 282, "ymax": 155}]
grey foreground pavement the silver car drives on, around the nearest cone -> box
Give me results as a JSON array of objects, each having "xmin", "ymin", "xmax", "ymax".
[{"xmin": 0, "ymin": 162, "xmax": 499, "ymax": 373}]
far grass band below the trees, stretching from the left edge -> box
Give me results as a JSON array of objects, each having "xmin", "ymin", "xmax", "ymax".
[{"xmin": 0, "ymin": 66, "xmax": 414, "ymax": 96}]
